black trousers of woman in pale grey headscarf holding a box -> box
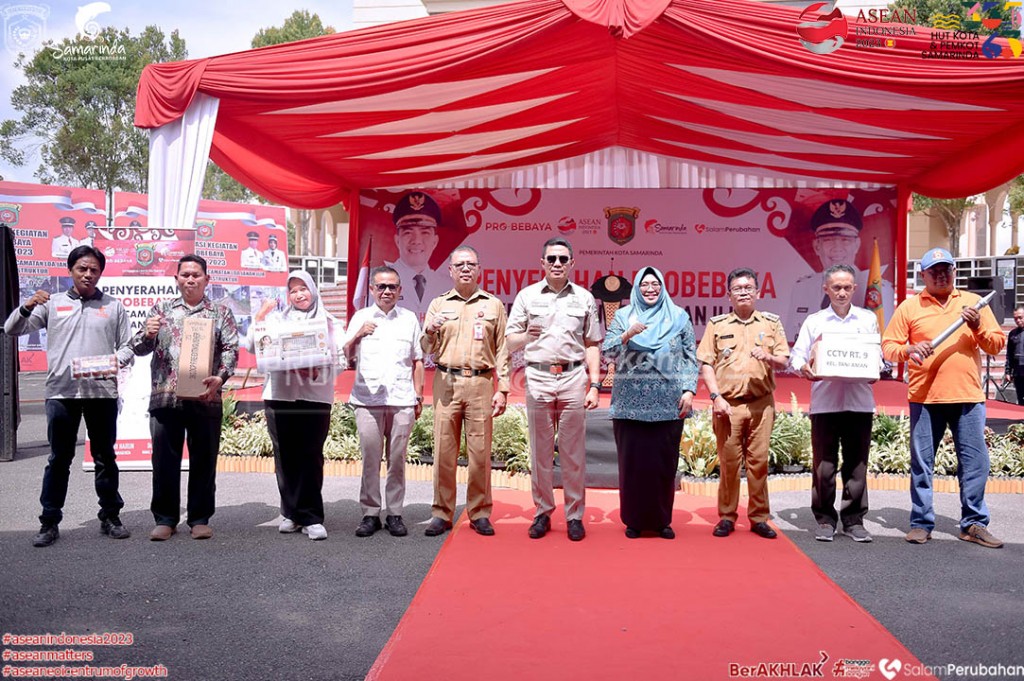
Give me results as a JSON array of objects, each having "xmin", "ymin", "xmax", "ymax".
[{"xmin": 265, "ymin": 399, "xmax": 331, "ymax": 526}]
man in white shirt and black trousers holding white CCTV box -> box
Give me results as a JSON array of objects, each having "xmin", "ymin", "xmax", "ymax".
[{"xmin": 791, "ymin": 264, "xmax": 879, "ymax": 542}]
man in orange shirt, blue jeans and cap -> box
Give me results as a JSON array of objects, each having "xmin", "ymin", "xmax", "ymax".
[{"xmin": 882, "ymin": 248, "xmax": 1007, "ymax": 549}]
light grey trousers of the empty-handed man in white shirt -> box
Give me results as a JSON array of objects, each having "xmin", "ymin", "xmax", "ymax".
[{"xmin": 354, "ymin": 407, "xmax": 416, "ymax": 515}]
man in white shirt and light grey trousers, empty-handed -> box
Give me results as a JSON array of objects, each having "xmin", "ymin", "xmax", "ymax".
[{"xmin": 345, "ymin": 266, "xmax": 423, "ymax": 537}]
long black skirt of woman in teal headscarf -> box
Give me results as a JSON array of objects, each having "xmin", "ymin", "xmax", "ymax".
[{"xmin": 611, "ymin": 419, "xmax": 683, "ymax": 531}]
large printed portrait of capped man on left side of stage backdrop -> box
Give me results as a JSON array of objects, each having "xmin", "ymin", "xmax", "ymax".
[{"xmin": 385, "ymin": 191, "xmax": 452, "ymax": 322}]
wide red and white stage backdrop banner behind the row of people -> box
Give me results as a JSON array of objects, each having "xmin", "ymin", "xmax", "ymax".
[{"xmin": 349, "ymin": 187, "xmax": 896, "ymax": 360}]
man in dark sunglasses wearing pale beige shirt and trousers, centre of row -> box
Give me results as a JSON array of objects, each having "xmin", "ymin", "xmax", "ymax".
[{"xmin": 508, "ymin": 237, "xmax": 603, "ymax": 542}]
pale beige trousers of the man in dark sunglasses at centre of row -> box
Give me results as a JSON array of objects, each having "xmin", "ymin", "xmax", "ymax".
[{"xmin": 526, "ymin": 367, "xmax": 589, "ymax": 520}]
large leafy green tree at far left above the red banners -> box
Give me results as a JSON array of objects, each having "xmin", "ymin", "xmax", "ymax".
[{"xmin": 0, "ymin": 26, "xmax": 188, "ymax": 193}]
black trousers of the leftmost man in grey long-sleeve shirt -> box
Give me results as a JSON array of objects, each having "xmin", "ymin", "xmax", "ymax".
[{"xmin": 39, "ymin": 397, "xmax": 125, "ymax": 525}]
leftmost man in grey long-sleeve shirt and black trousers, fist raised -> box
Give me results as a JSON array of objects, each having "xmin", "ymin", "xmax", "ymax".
[{"xmin": 4, "ymin": 246, "xmax": 134, "ymax": 547}]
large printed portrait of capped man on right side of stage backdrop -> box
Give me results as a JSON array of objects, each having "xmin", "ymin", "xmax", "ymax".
[{"xmin": 783, "ymin": 199, "xmax": 895, "ymax": 341}]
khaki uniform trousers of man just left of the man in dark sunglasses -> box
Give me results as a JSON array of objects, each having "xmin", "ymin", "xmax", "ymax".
[{"xmin": 430, "ymin": 371, "xmax": 495, "ymax": 522}]
